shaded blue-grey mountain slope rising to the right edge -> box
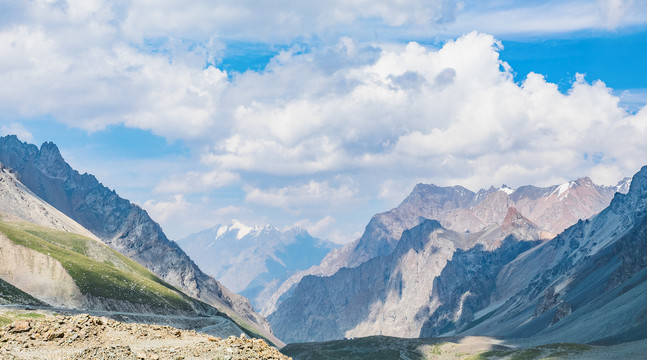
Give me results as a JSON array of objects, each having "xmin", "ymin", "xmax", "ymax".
[{"xmin": 448, "ymin": 167, "xmax": 647, "ymax": 343}]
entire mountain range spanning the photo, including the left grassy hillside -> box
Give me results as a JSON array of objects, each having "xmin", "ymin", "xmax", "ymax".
[{"xmin": 0, "ymin": 136, "xmax": 647, "ymax": 354}]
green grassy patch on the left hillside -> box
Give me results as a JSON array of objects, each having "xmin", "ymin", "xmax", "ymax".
[{"xmin": 0, "ymin": 220, "xmax": 200, "ymax": 311}]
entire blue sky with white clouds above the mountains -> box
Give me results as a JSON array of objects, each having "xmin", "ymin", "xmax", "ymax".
[{"xmin": 0, "ymin": 0, "xmax": 647, "ymax": 242}]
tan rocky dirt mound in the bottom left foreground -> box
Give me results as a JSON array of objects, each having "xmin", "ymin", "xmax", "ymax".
[{"xmin": 0, "ymin": 315, "xmax": 290, "ymax": 360}]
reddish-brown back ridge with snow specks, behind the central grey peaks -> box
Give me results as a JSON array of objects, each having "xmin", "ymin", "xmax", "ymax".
[{"xmin": 263, "ymin": 178, "xmax": 631, "ymax": 330}]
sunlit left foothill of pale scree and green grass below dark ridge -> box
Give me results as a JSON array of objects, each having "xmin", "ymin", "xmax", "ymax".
[{"xmin": 0, "ymin": 168, "xmax": 230, "ymax": 327}]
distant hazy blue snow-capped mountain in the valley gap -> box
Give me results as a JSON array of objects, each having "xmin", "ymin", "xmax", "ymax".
[{"xmin": 178, "ymin": 220, "xmax": 337, "ymax": 309}]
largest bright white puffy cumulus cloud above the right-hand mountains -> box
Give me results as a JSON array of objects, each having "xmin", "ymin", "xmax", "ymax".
[{"xmin": 199, "ymin": 33, "xmax": 644, "ymax": 191}]
